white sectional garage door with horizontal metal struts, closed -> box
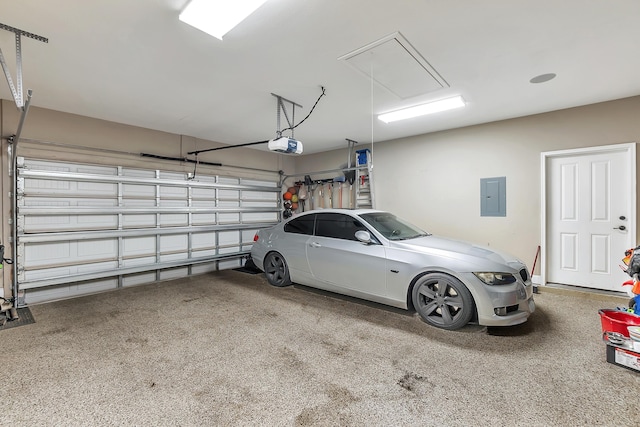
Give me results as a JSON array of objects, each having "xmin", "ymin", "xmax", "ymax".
[{"xmin": 16, "ymin": 158, "xmax": 280, "ymax": 304}]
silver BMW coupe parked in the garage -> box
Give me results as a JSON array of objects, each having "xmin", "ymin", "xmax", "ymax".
[{"xmin": 251, "ymin": 209, "xmax": 535, "ymax": 329}]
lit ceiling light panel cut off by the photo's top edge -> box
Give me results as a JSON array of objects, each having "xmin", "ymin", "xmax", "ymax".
[{"xmin": 178, "ymin": 0, "xmax": 267, "ymax": 40}]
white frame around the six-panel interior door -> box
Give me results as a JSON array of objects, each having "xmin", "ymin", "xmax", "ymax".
[{"xmin": 531, "ymin": 142, "xmax": 637, "ymax": 286}]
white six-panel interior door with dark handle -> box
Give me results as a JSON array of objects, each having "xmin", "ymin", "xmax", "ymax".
[{"xmin": 545, "ymin": 144, "xmax": 636, "ymax": 291}]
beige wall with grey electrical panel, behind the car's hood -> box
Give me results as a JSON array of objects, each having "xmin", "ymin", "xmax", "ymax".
[{"xmin": 297, "ymin": 97, "xmax": 640, "ymax": 271}]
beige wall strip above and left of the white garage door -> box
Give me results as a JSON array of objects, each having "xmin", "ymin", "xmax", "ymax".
[{"xmin": 0, "ymin": 100, "xmax": 295, "ymax": 296}]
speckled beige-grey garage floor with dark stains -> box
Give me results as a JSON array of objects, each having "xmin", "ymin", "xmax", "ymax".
[{"xmin": 0, "ymin": 271, "xmax": 640, "ymax": 426}]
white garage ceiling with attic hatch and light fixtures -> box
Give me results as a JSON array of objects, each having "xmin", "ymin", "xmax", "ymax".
[{"xmin": 0, "ymin": 0, "xmax": 640, "ymax": 153}]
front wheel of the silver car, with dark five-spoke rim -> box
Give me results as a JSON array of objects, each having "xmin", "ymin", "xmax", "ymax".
[{"xmin": 411, "ymin": 273, "xmax": 475, "ymax": 330}]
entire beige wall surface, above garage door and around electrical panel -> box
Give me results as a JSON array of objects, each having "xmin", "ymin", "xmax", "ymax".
[{"xmin": 0, "ymin": 97, "xmax": 640, "ymax": 295}]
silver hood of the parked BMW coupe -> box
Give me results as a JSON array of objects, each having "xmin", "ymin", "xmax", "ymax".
[{"xmin": 390, "ymin": 235, "xmax": 524, "ymax": 271}]
